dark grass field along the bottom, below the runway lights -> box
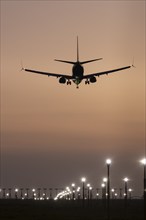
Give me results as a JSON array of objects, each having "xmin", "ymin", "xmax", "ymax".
[{"xmin": 0, "ymin": 199, "xmax": 144, "ymax": 220}]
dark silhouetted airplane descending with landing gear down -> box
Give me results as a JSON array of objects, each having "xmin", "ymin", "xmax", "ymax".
[{"xmin": 22, "ymin": 37, "xmax": 133, "ymax": 88}]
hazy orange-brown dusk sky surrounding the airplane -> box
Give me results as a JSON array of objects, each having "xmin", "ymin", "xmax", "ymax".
[{"xmin": 0, "ymin": 1, "xmax": 146, "ymax": 195}]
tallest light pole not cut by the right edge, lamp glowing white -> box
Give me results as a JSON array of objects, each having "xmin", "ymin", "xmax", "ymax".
[{"xmin": 106, "ymin": 159, "xmax": 112, "ymax": 220}]
